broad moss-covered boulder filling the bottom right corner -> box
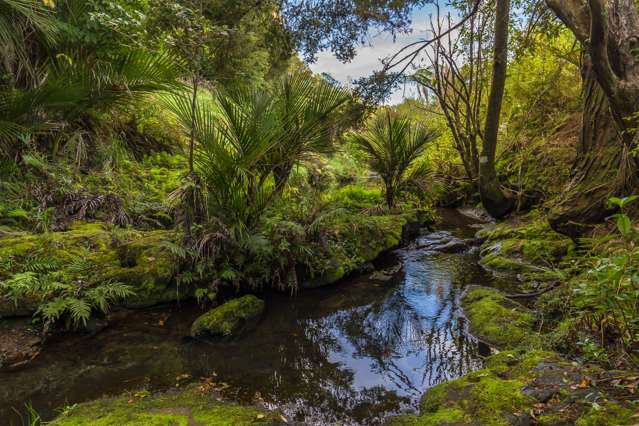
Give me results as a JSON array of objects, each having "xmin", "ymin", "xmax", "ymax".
[{"xmin": 390, "ymin": 350, "xmax": 633, "ymax": 426}]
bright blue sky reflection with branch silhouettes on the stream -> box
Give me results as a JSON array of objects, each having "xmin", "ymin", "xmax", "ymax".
[{"xmin": 309, "ymin": 245, "xmax": 476, "ymax": 399}]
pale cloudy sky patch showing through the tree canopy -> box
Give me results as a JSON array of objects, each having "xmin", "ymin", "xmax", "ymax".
[{"xmin": 310, "ymin": 6, "xmax": 440, "ymax": 105}]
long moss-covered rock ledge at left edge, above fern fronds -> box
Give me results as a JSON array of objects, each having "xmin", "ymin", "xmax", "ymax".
[{"xmin": 0, "ymin": 223, "xmax": 184, "ymax": 318}]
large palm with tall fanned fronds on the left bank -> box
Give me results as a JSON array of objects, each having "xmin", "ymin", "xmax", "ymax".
[{"xmin": 162, "ymin": 72, "xmax": 349, "ymax": 230}]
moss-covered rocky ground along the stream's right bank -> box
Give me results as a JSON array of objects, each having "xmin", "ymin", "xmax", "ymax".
[{"xmin": 398, "ymin": 220, "xmax": 638, "ymax": 426}]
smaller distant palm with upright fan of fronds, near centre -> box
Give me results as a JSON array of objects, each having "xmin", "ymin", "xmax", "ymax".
[{"xmin": 350, "ymin": 110, "xmax": 437, "ymax": 208}]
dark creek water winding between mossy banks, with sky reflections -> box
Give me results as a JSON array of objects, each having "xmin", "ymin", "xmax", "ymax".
[{"xmin": 0, "ymin": 211, "xmax": 508, "ymax": 425}]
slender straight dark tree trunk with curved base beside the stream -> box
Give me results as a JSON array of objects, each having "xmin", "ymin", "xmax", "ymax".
[{"xmin": 479, "ymin": 0, "xmax": 514, "ymax": 218}]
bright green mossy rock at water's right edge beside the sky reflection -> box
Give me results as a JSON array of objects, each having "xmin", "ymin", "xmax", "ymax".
[{"xmin": 462, "ymin": 286, "xmax": 541, "ymax": 349}]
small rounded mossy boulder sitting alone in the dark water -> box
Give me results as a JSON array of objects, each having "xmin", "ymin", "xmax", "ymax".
[{"xmin": 191, "ymin": 295, "xmax": 264, "ymax": 339}]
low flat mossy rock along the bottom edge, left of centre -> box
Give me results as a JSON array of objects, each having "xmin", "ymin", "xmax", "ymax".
[{"xmin": 49, "ymin": 387, "xmax": 283, "ymax": 426}]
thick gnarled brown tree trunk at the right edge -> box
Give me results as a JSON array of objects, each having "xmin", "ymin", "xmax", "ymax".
[{"xmin": 546, "ymin": 0, "xmax": 639, "ymax": 237}]
